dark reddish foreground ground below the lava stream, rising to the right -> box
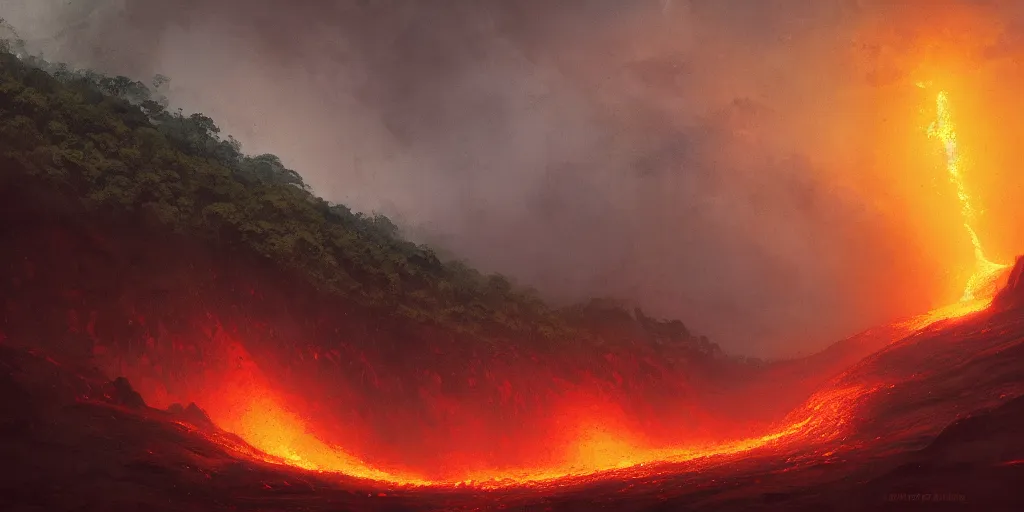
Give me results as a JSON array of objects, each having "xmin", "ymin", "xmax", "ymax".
[{"xmin": 0, "ymin": 266, "xmax": 1024, "ymax": 511}]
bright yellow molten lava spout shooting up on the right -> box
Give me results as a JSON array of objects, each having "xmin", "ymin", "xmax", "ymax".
[{"xmin": 928, "ymin": 91, "xmax": 1009, "ymax": 303}]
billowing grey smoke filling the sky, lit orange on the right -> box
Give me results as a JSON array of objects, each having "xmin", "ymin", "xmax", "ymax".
[{"xmin": 0, "ymin": 0, "xmax": 1024, "ymax": 355}]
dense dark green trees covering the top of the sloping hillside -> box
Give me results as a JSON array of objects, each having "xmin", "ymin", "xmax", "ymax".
[{"xmin": 0, "ymin": 28, "xmax": 719, "ymax": 356}]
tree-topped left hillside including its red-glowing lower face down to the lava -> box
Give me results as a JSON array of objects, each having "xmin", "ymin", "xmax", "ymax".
[{"xmin": 0, "ymin": 42, "xmax": 761, "ymax": 481}]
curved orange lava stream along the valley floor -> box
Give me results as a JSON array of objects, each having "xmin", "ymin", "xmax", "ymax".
[{"xmin": 183, "ymin": 368, "xmax": 870, "ymax": 488}]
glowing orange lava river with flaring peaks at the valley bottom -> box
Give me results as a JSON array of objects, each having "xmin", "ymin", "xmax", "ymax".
[{"xmin": 128, "ymin": 329, "xmax": 871, "ymax": 488}]
